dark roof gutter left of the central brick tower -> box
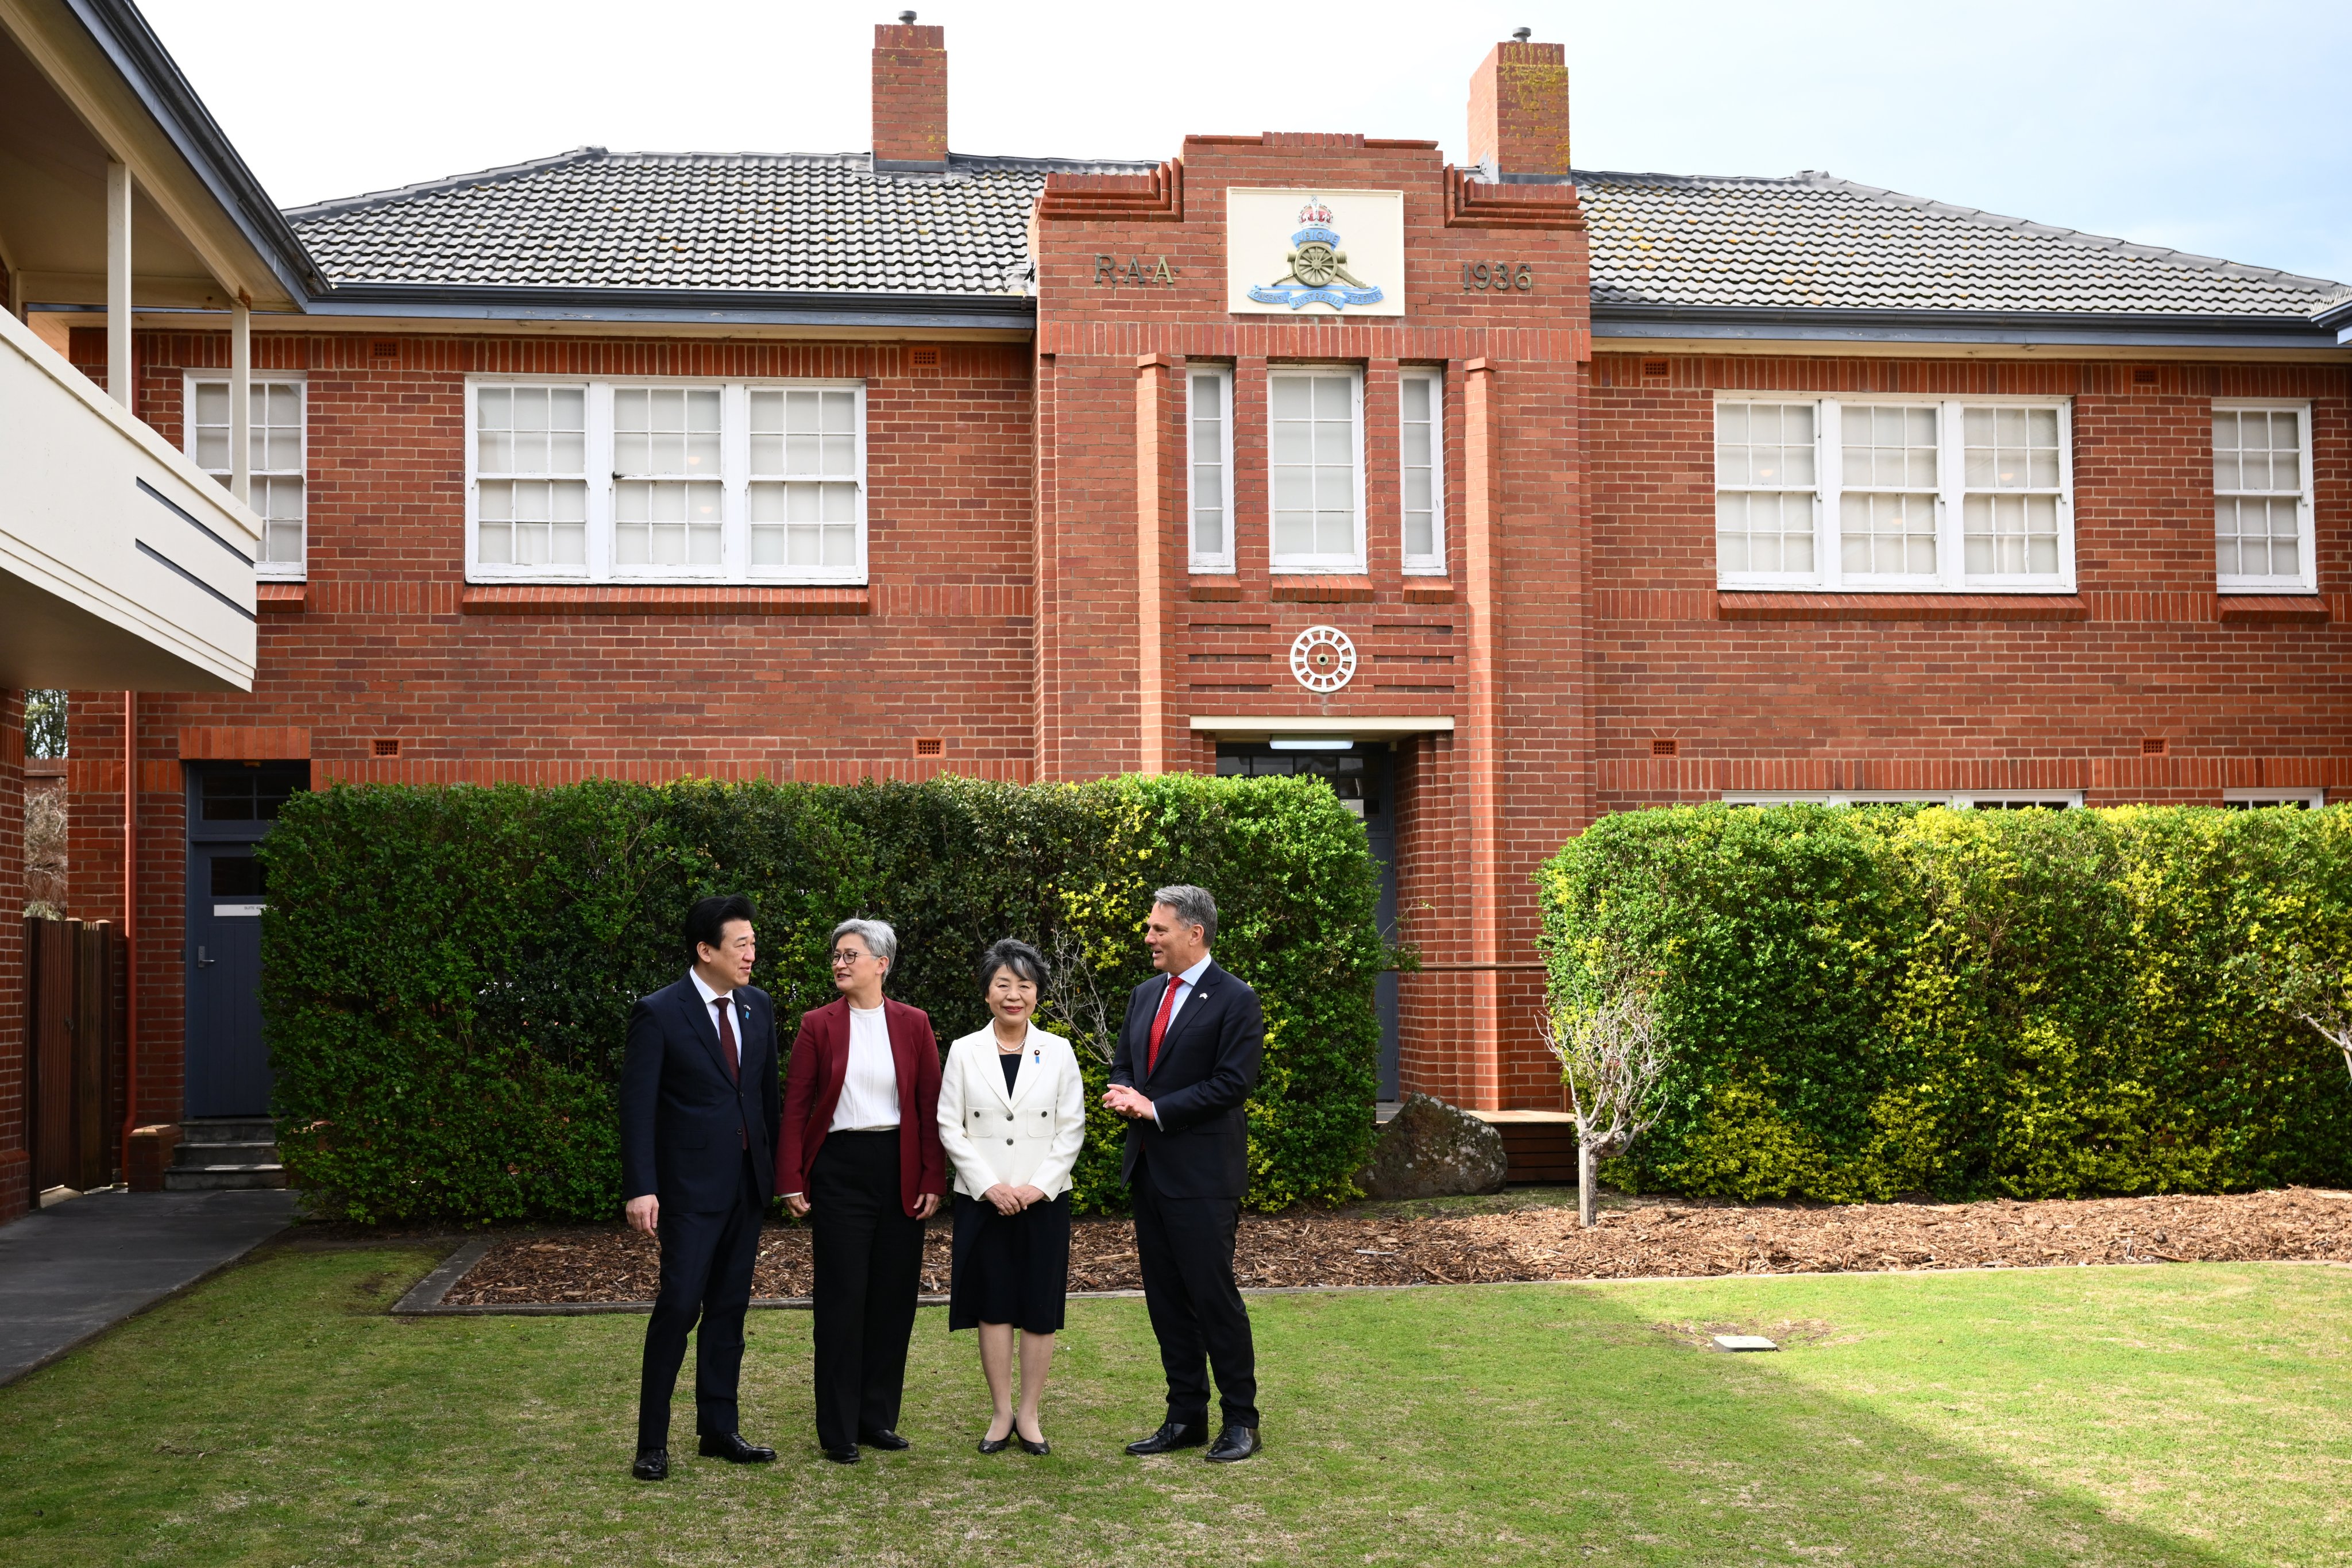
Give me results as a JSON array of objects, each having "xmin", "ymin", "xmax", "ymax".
[{"xmin": 311, "ymin": 282, "xmax": 1037, "ymax": 331}]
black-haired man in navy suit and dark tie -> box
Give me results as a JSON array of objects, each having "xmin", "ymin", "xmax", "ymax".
[{"xmin": 621, "ymin": 893, "xmax": 781, "ymax": 1481}]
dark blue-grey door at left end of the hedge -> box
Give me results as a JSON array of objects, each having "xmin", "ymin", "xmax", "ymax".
[{"xmin": 183, "ymin": 762, "xmax": 311, "ymax": 1119}]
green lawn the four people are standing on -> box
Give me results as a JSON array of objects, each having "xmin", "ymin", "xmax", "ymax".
[{"xmin": 0, "ymin": 1246, "xmax": 2352, "ymax": 1568}]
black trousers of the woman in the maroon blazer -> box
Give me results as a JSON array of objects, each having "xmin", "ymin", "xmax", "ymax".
[{"xmin": 809, "ymin": 1131, "xmax": 922, "ymax": 1448}]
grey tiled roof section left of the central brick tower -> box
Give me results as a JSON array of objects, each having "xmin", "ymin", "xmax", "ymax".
[{"xmin": 287, "ymin": 148, "xmax": 1157, "ymax": 296}]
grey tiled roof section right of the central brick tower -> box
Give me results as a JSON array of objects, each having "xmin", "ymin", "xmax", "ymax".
[{"xmin": 1574, "ymin": 172, "xmax": 2352, "ymax": 318}]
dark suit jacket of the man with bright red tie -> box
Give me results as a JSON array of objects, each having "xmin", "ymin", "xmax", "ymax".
[{"xmin": 1110, "ymin": 961, "xmax": 1265, "ymax": 1199}]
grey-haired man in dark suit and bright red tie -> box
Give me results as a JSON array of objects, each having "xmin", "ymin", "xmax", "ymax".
[{"xmin": 1103, "ymin": 886, "xmax": 1265, "ymax": 1465}]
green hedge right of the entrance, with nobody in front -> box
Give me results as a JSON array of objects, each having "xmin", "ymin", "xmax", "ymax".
[{"xmin": 1538, "ymin": 806, "xmax": 2352, "ymax": 1201}]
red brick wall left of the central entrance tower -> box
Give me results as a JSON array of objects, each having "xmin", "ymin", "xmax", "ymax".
[{"xmin": 68, "ymin": 331, "xmax": 1035, "ymax": 1119}]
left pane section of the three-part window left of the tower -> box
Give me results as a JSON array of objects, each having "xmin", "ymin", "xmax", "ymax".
[{"xmin": 473, "ymin": 385, "xmax": 588, "ymax": 571}]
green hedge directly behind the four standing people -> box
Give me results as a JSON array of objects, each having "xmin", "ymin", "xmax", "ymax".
[{"xmin": 261, "ymin": 776, "xmax": 1388, "ymax": 1222}]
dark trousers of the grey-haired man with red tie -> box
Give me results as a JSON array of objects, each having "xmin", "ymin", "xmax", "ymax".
[{"xmin": 1131, "ymin": 1161, "xmax": 1258, "ymax": 1427}]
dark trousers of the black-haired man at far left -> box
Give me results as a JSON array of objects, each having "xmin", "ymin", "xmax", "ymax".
[{"xmin": 638, "ymin": 1157, "xmax": 762, "ymax": 1450}]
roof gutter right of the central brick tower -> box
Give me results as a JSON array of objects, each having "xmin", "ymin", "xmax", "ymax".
[{"xmin": 1592, "ymin": 301, "xmax": 2345, "ymax": 348}]
